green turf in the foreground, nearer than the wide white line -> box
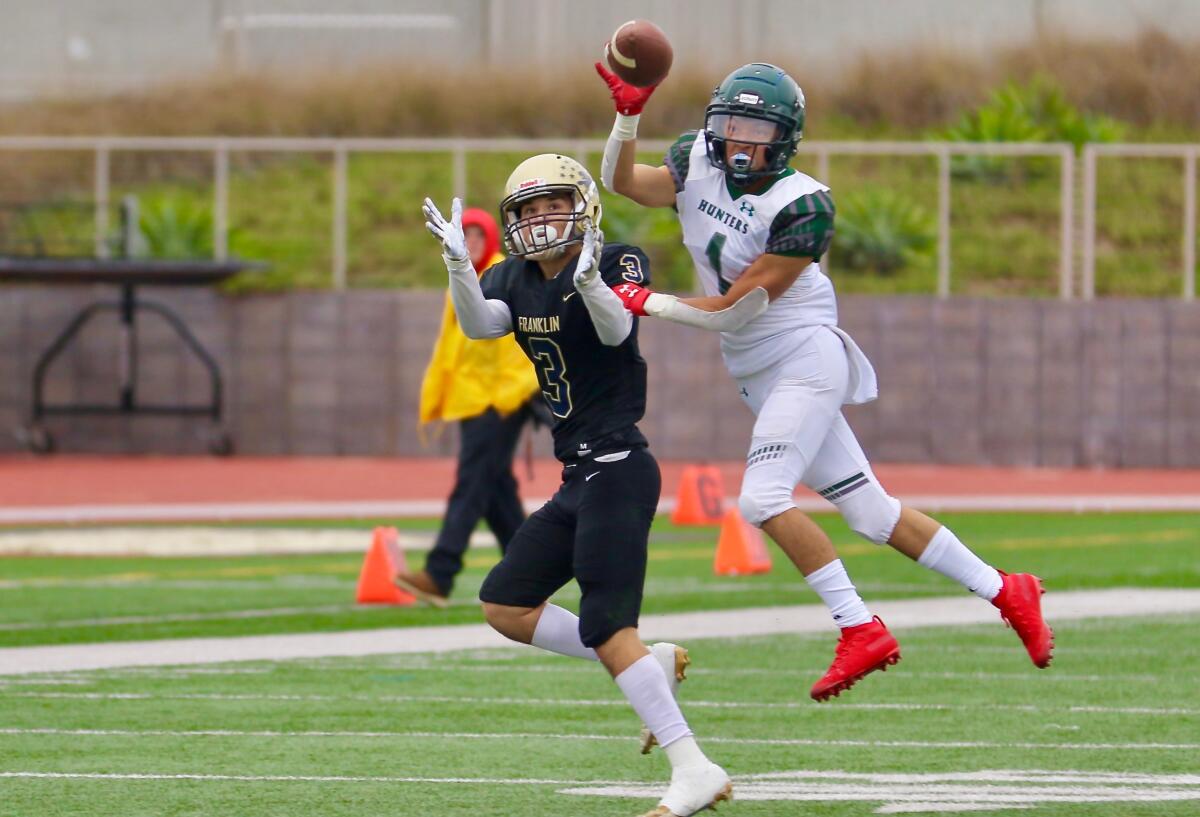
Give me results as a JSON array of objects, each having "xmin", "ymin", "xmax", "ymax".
[{"xmin": 0, "ymin": 617, "xmax": 1200, "ymax": 817}]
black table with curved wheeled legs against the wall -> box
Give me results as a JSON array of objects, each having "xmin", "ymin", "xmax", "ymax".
[{"xmin": 0, "ymin": 257, "xmax": 263, "ymax": 455}]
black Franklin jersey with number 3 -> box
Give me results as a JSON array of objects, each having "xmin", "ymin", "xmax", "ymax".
[{"xmin": 480, "ymin": 244, "xmax": 650, "ymax": 462}]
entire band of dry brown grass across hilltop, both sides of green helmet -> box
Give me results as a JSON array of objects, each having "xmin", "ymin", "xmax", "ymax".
[{"xmin": 7, "ymin": 31, "xmax": 1200, "ymax": 138}]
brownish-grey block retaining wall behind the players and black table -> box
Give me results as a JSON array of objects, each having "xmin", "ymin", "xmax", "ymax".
[{"xmin": 0, "ymin": 287, "xmax": 1200, "ymax": 467}]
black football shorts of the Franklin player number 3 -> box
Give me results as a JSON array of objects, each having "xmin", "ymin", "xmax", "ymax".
[{"xmin": 479, "ymin": 447, "xmax": 662, "ymax": 647}]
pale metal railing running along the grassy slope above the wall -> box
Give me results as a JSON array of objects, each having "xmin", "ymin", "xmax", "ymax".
[{"xmin": 0, "ymin": 136, "xmax": 1200, "ymax": 300}]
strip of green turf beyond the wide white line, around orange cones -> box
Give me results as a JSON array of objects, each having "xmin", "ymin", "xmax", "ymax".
[{"xmin": 0, "ymin": 513, "xmax": 1200, "ymax": 647}]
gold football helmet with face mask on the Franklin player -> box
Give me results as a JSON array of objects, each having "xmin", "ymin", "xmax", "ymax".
[{"xmin": 500, "ymin": 154, "xmax": 600, "ymax": 260}]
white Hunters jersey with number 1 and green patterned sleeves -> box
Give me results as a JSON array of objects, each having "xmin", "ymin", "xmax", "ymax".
[{"xmin": 666, "ymin": 132, "xmax": 875, "ymax": 402}]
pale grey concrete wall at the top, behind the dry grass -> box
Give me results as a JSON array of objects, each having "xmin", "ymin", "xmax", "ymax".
[{"xmin": 0, "ymin": 0, "xmax": 1200, "ymax": 100}]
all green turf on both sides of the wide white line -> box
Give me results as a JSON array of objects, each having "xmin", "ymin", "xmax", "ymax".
[{"xmin": 0, "ymin": 513, "xmax": 1200, "ymax": 817}]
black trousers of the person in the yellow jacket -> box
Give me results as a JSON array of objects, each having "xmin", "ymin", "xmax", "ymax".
[{"xmin": 425, "ymin": 403, "xmax": 529, "ymax": 595}]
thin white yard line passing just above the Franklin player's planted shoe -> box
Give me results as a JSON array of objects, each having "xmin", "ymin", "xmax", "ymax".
[{"xmin": 0, "ymin": 727, "xmax": 1200, "ymax": 752}]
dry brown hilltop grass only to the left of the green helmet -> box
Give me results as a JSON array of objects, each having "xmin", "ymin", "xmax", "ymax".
[{"xmin": 0, "ymin": 65, "xmax": 712, "ymax": 137}]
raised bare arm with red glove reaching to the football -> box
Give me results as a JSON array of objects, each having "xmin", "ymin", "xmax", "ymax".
[{"xmin": 595, "ymin": 62, "xmax": 676, "ymax": 208}]
